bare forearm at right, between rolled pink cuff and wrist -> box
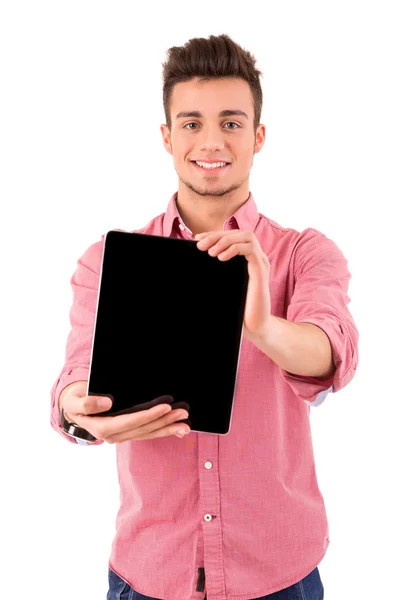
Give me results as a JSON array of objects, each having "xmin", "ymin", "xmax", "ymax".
[{"xmin": 251, "ymin": 315, "xmax": 336, "ymax": 379}]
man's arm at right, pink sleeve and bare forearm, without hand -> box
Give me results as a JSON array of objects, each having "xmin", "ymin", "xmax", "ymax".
[{"xmin": 251, "ymin": 228, "xmax": 359, "ymax": 406}]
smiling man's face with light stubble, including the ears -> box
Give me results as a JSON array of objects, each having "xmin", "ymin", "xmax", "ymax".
[{"xmin": 161, "ymin": 78, "xmax": 265, "ymax": 196}]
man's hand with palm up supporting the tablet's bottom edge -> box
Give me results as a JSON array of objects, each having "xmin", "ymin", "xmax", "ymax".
[{"xmin": 59, "ymin": 381, "xmax": 190, "ymax": 444}]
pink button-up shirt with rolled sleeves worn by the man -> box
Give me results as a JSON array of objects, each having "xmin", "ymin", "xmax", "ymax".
[{"xmin": 51, "ymin": 193, "xmax": 358, "ymax": 600}]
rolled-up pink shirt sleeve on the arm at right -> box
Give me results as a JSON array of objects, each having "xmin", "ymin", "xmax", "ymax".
[{"xmin": 280, "ymin": 228, "xmax": 359, "ymax": 406}]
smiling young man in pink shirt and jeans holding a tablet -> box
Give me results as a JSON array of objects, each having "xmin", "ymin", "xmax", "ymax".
[{"xmin": 51, "ymin": 35, "xmax": 358, "ymax": 600}]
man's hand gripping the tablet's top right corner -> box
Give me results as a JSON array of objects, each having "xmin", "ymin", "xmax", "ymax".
[{"xmin": 195, "ymin": 229, "xmax": 271, "ymax": 340}]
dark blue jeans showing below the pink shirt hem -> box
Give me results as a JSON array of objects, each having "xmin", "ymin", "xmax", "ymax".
[{"xmin": 107, "ymin": 567, "xmax": 324, "ymax": 600}]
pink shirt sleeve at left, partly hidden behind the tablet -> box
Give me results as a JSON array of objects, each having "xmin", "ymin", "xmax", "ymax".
[{"xmin": 50, "ymin": 236, "xmax": 104, "ymax": 446}]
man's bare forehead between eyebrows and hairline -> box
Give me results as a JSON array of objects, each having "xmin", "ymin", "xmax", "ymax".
[{"xmin": 171, "ymin": 78, "xmax": 254, "ymax": 119}]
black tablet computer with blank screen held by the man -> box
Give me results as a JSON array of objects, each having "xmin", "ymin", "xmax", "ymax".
[{"xmin": 87, "ymin": 230, "xmax": 248, "ymax": 435}]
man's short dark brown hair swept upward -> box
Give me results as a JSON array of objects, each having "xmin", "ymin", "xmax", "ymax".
[{"xmin": 162, "ymin": 34, "xmax": 263, "ymax": 132}]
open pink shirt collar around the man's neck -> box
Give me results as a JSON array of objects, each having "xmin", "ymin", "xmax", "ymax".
[{"xmin": 163, "ymin": 192, "xmax": 259, "ymax": 237}]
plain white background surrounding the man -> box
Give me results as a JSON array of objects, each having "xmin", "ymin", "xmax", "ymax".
[{"xmin": 0, "ymin": 0, "xmax": 400, "ymax": 600}]
